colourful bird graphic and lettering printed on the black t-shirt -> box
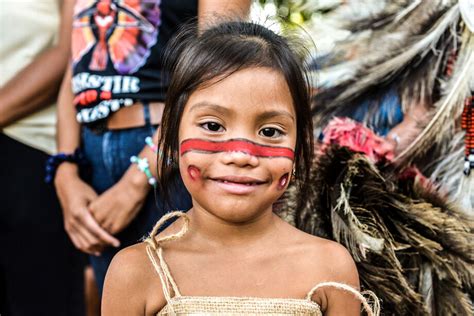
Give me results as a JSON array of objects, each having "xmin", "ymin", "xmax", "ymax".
[{"xmin": 72, "ymin": 0, "xmax": 161, "ymax": 123}]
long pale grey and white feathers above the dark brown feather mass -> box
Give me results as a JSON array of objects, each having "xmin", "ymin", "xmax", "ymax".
[{"xmin": 306, "ymin": 0, "xmax": 474, "ymax": 216}]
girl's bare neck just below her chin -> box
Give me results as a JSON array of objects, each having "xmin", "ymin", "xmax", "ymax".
[{"xmin": 188, "ymin": 206, "xmax": 278, "ymax": 248}]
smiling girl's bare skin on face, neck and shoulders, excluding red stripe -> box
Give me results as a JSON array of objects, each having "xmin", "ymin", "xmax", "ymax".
[{"xmin": 102, "ymin": 68, "xmax": 360, "ymax": 315}]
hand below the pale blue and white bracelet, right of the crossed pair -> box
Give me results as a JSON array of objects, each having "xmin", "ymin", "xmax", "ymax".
[{"xmin": 89, "ymin": 167, "xmax": 150, "ymax": 235}]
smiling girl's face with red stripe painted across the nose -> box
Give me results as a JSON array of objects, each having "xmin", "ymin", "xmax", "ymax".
[{"xmin": 179, "ymin": 68, "xmax": 296, "ymax": 222}]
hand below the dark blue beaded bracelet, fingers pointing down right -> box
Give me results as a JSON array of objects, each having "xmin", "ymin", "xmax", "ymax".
[{"xmin": 54, "ymin": 163, "xmax": 120, "ymax": 255}]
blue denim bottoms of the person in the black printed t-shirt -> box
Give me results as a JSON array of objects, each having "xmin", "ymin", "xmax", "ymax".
[{"xmin": 82, "ymin": 116, "xmax": 192, "ymax": 293}]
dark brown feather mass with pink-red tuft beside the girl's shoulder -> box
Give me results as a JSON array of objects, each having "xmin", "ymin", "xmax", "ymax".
[{"xmin": 280, "ymin": 118, "xmax": 474, "ymax": 315}]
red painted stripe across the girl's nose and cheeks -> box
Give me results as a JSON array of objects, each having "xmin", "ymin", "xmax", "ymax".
[{"xmin": 180, "ymin": 138, "xmax": 295, "ymax": 160}]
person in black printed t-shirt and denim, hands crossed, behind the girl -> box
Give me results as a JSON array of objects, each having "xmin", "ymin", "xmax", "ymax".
[{"xmin": 54, "ymin": 0, "xmax": 250, "ymax": 290}]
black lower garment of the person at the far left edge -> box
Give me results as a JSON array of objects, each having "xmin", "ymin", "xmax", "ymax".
[{"xmin": 0, "ymin": 134, "xmax": 84, "ymax": 315}]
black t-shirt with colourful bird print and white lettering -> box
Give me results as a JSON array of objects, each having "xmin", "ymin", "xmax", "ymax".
[{"xmin": 72, "ymin": 0, "xmax": 197, "ymax": 124}]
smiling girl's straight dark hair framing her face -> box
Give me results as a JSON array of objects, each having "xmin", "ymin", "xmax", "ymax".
[{"xmin": 158, "ymin": 21, "xmax": 313, "ymax": 211}]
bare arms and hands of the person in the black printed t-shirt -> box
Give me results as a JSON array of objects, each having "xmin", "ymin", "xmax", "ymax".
[{"xmin": 55, "ymin": 0, "xmax": 251, "ymax": 255}]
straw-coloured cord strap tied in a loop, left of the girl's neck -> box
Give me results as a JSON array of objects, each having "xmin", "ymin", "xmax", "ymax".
[{"xmin": 145, "ymin": 212, "xmax": 189, "ymax": 304}]
